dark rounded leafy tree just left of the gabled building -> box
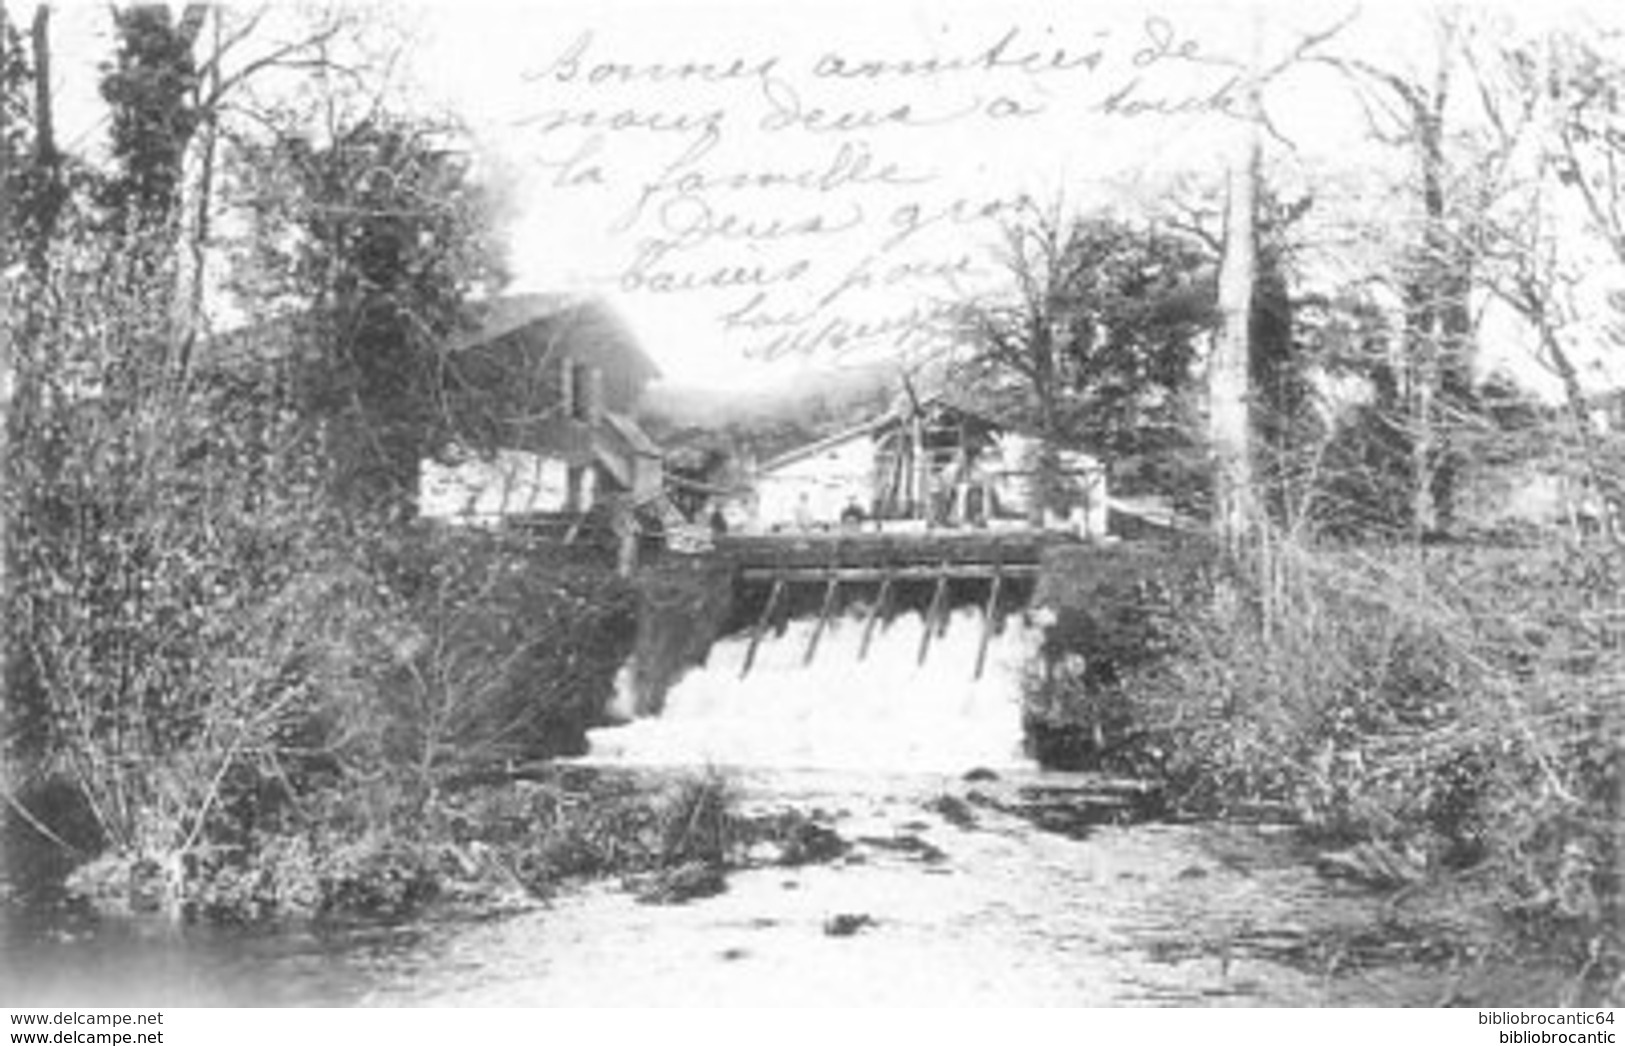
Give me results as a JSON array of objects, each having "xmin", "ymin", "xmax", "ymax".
[{"xmin": 241, "ymin": 114, "xmax": 505, "ymax": 517}]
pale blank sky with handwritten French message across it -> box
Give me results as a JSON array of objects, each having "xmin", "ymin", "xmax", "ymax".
[{"xmin": 34, "ymin": 0, "xmax": 1625, "ymax": 401}]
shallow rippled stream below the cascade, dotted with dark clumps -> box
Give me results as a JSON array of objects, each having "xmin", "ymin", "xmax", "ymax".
[{"xmin": 0, "ymin": 768, "xmax": 1508, "ymax": 1005}]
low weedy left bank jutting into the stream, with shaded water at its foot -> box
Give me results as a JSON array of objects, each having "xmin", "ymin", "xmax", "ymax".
[{"xmin": 0, "ymin": 763, "xmax": 843, "ymax": 1005}]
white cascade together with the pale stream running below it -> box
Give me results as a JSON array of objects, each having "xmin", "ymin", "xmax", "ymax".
[{"xmin": 0, "ymin": 611, "xmax": 1475, "ymax": 1005}]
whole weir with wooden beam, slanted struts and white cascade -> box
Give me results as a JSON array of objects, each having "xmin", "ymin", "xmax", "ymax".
[{"xmin": 592, "ymin": 529, "xmax": 1185, "ymax": 772}]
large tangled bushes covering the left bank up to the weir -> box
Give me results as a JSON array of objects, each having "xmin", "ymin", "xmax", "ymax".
[{"xmin": 0, "ymin": 141, "xmax": 634, "ymax": 929}]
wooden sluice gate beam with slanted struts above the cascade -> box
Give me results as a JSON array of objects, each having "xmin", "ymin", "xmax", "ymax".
[{"xmin": 713, "ymin": 529, "xmax": 1077, "ymax": 679}]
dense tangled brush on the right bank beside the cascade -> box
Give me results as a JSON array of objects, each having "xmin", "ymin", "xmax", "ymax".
[{"xmin": 1027, "ymin": 541, "xmax": 1625, "ymax": 1000}]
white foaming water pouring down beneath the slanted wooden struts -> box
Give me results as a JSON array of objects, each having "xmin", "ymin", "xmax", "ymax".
[{"xmin": 592, "ymin": 607, "xmax": 1038, "ymax": 773}]
